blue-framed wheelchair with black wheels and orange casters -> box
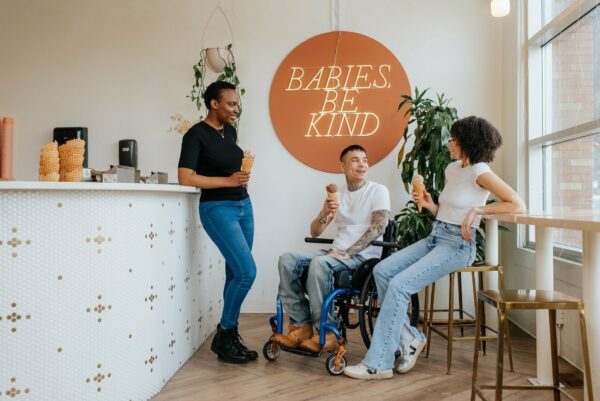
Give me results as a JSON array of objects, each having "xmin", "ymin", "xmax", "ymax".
[{"xmin": 263, "ymin": 220, "xmax": 419, "ymax": 376}]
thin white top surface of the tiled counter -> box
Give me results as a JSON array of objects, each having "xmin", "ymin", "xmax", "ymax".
[{"xmin": 0, "ymin": 181, "xmax": 200, "ymax": 194}]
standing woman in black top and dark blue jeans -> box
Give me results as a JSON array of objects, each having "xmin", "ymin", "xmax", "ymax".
[{"xmin": 178, "ymin": 81, "xmax": 258, "ymax": 363}]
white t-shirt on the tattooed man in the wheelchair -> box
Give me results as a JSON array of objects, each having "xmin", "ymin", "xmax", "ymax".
[{"xmin": 333, "ymin": 181, "xmax": 390, "ymax": 259}]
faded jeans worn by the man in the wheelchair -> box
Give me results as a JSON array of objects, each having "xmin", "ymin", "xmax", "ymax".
[{"xmin": 278, "ymin": 250, "xmax": 365, "ymax": 330}]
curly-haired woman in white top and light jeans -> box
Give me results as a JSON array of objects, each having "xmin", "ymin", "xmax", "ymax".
[{"xmin": 344, "ymin": 117, "xmax": 525, "ymax": 379}]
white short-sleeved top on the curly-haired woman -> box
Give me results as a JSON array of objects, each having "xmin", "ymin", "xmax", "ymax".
[{"xmin": 437, "ymin": 160, "xmax": 492, "ymax": 227}]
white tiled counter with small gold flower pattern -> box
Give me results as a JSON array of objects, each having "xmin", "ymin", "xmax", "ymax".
[{"xmin": 0, "ymin": 182, "xmax": 225, "ymax": 401}]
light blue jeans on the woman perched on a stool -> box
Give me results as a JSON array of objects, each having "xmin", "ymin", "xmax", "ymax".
[{"xmin": 363, "ymin": 220, "xmax": 476, "ymax": 370}]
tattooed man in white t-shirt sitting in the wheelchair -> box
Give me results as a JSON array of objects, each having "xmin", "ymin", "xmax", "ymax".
[{"xmin": 273, "ymin": 145, "xmax": 390, "ymax": 353}]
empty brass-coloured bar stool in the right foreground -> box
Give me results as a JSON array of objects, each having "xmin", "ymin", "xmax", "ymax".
[{"xmin": 471, "ymin": 290, "xmax": 594, "ymax": 401}]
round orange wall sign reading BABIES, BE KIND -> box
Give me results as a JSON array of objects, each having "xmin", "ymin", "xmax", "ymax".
[{"xmin": 269, "ymin": 32, "xmax": 410, "ymax": 173}]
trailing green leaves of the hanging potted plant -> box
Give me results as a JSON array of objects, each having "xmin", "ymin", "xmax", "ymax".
[{"xmin": 187, "ymin": 43, "xmax": 246, "ymax": 128}]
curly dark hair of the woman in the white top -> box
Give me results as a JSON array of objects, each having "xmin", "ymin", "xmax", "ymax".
[{"xmin": 450, "ymin": 116, "xmax": 502, "ymax": 164}]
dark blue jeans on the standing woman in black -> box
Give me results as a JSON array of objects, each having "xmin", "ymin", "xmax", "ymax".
[{"xmin": 200, "ymin": 198, "xmax": 256, "ymax": 329}]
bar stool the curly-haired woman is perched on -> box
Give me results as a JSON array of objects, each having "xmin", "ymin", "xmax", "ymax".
[{"xmin": 423, "ymin": 265, "xmax": 513, "ymax": 374}]
